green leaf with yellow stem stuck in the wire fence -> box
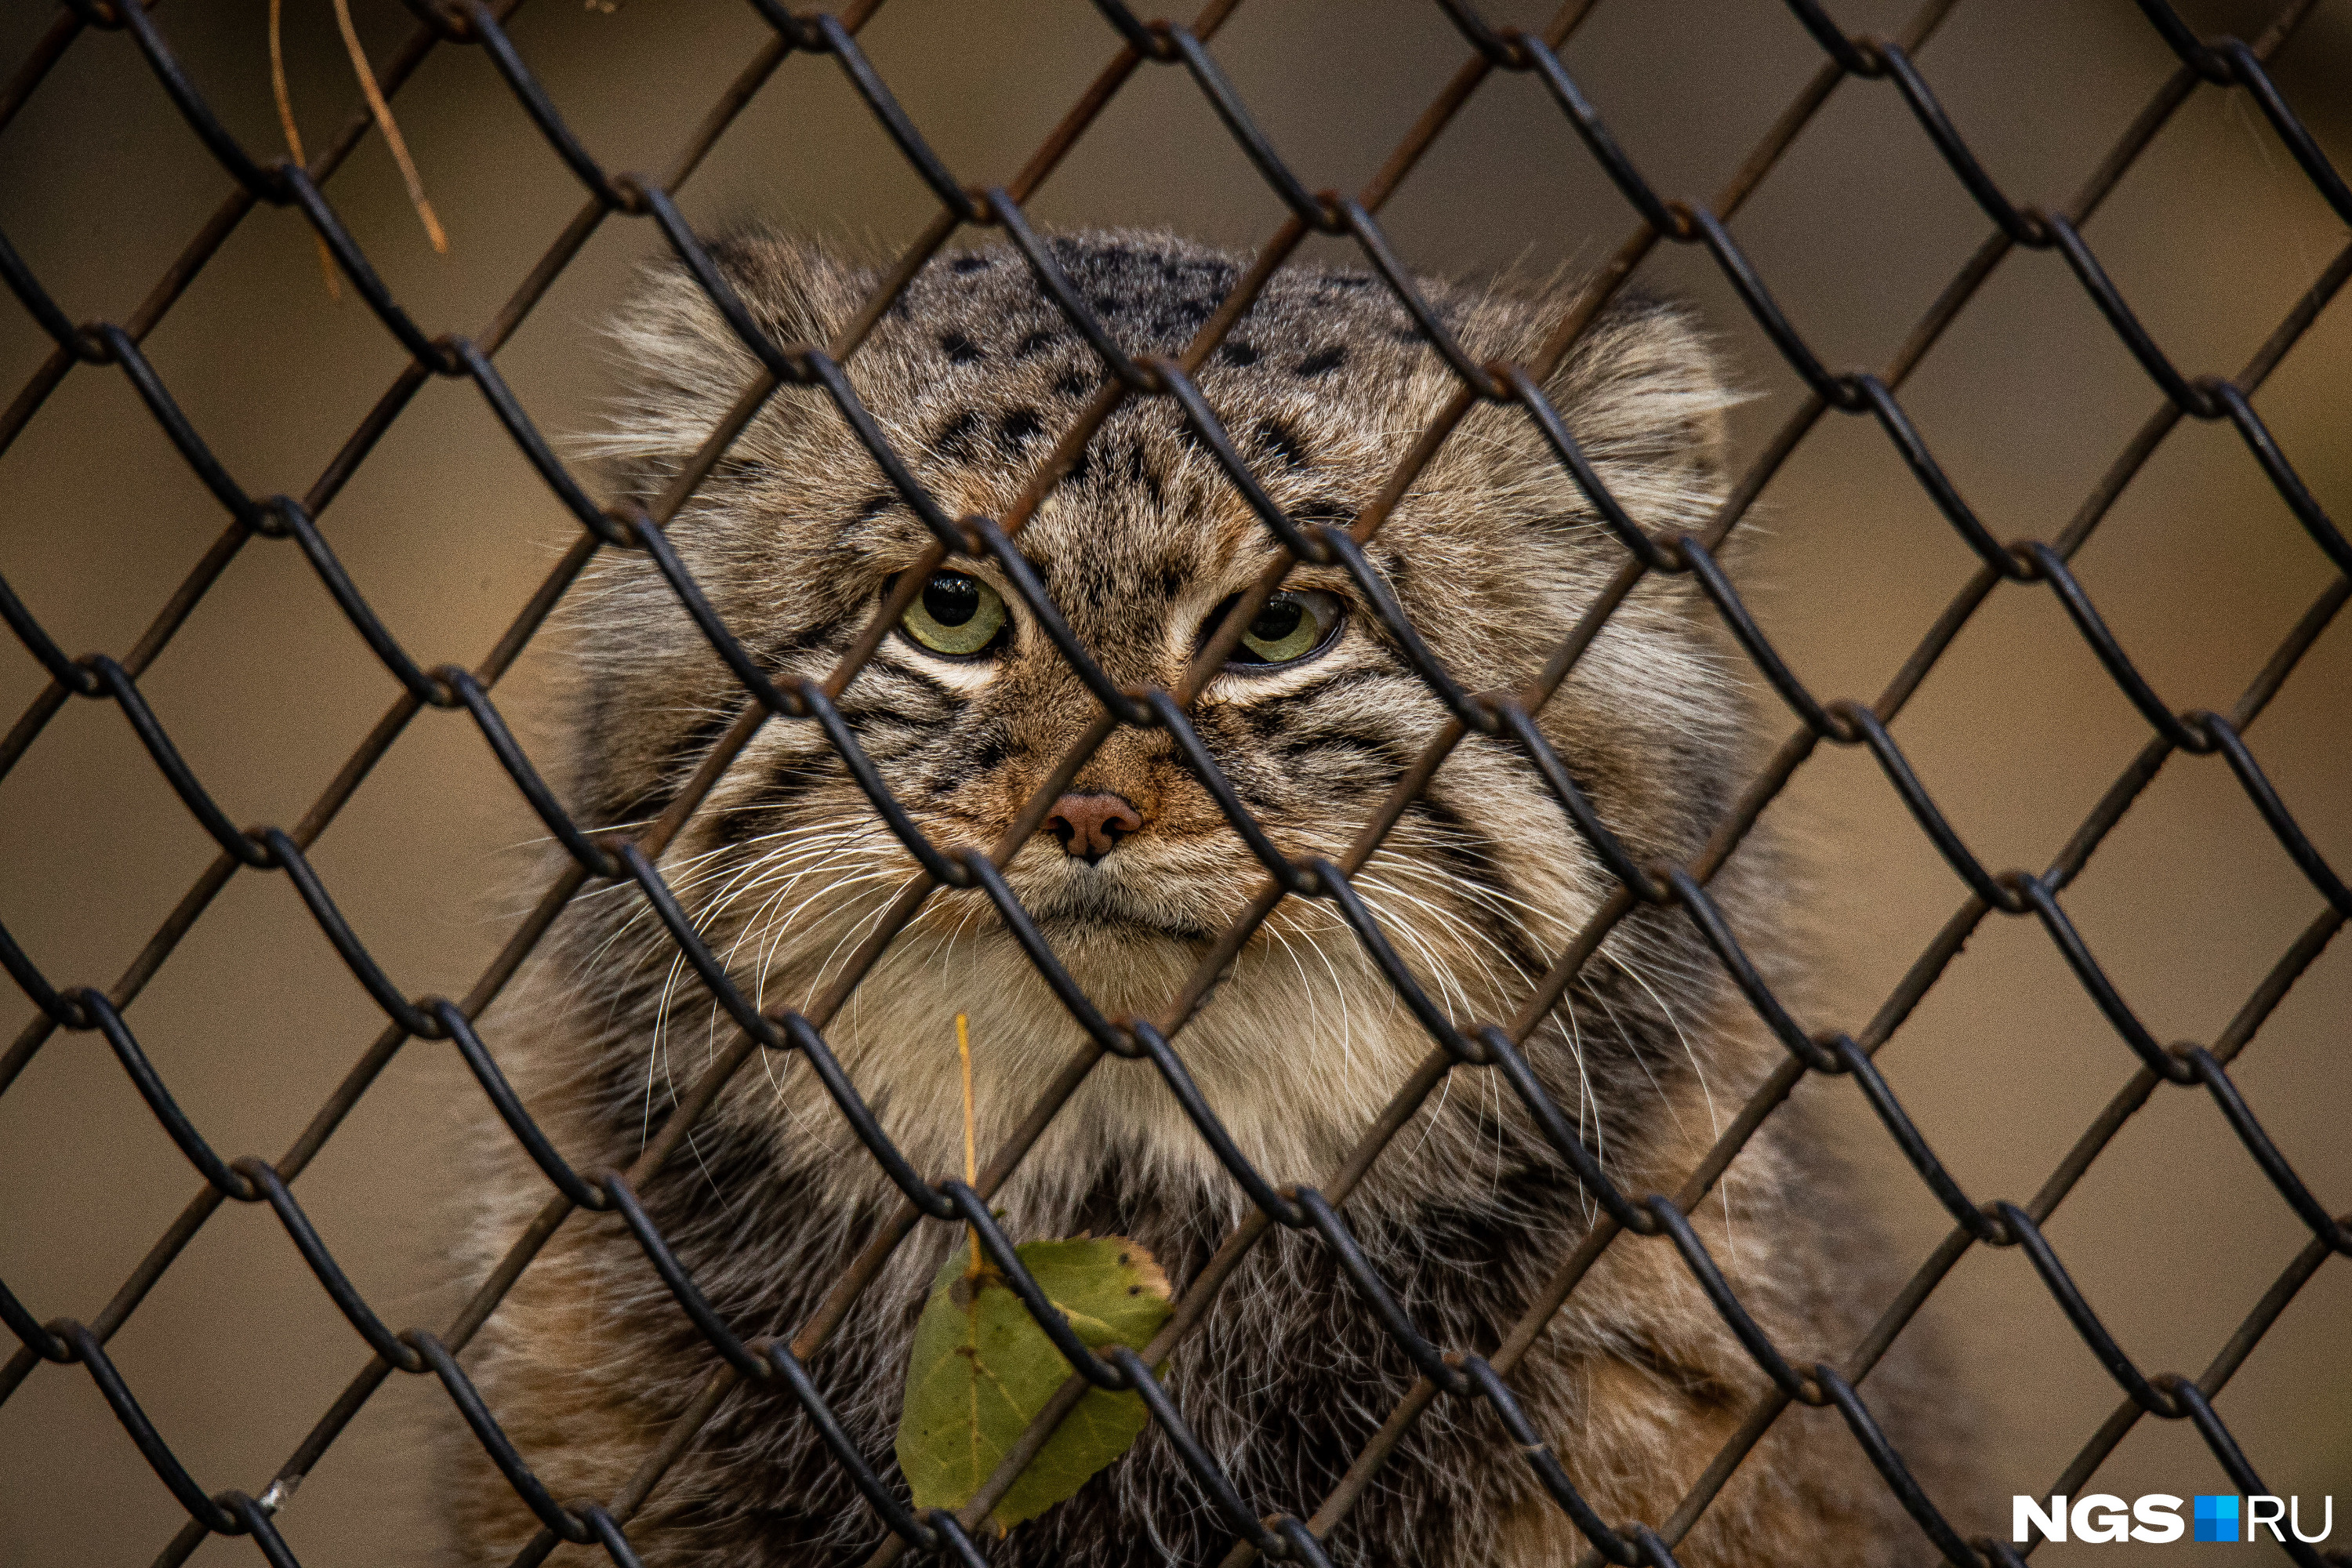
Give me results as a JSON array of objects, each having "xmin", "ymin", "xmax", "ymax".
[{"xmin": 898, "ymin": 1236, "xmax": 1169, "ymax": 1530}]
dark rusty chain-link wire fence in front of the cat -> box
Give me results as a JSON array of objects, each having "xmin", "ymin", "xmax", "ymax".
[{"xmin": 0, "ymin": 0, "xmax": 2352, "ymax": 1566}]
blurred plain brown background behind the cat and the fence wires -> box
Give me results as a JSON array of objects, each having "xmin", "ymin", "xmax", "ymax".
[{"xmin": 0, "ymin": 0, "xmax": 2352, "ymax": 1568}]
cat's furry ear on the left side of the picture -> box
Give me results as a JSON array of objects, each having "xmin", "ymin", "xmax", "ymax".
[{"xmin": 581, "ymin": 230, "xmax": 866, "ymax": 496}]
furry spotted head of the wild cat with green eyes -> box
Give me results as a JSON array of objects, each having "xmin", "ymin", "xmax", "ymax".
[{"xmin": 560, "ymin": 233, "xmax": 1745, "ymax": 1203}]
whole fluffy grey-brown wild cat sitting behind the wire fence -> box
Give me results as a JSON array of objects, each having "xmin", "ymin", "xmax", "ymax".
[{"xmin": 456, "ymin": 235, "xmax": 1966, "ymax": 1568}]
